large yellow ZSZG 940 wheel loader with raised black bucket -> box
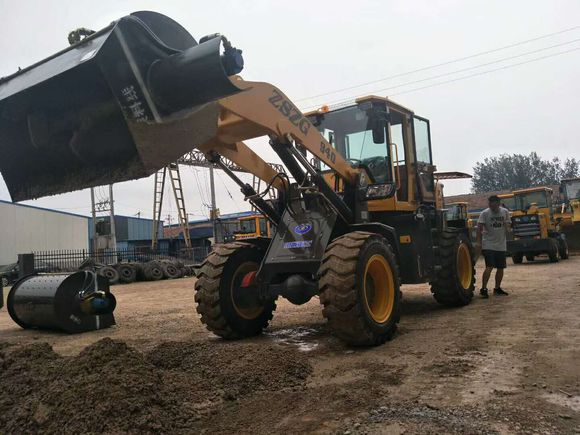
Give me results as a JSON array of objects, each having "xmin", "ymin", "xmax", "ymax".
[{"xmin": 0, "ymin": 12, "xmax": 475, "ymax": 346}]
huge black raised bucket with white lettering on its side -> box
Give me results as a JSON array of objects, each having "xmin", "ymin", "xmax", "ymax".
[{"xmin": 0, "ymin": 11, "xmax": 243, "ymax": 201}]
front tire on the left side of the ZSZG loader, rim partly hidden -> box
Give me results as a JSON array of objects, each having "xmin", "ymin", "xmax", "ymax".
[{"xmin": 195, "ymin": 242, "xmax": 276, "ymax": 340}]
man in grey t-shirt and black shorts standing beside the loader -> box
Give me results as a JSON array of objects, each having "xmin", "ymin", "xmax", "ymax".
[{"xmin": 475, "ymin": 195, "xmax": 510, "ymax": 298}]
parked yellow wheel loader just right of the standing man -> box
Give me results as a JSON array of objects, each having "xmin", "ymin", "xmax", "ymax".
[{"xmin": 507, "ymin": 187, "xmax": 569, "ymax": 264}]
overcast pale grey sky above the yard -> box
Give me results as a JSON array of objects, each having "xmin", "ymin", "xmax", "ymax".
[{"xmin": 0, "ymin": 0, "xmax": 580, "ymax": 223}]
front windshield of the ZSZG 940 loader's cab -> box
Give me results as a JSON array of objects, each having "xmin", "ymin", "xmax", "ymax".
[{"xmin": 312, "ymin": 106, "xmax": 390, "ymax": 183}]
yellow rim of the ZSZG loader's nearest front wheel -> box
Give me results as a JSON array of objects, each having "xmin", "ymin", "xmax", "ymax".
[{"xmin": 363, "ymin": 254, "xmax": 395, "ymax": 323}]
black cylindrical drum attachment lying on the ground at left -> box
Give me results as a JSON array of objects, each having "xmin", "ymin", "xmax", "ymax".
[{"xmin": 6, "ymin": 271, "xmax": 116, "ymax": 333}]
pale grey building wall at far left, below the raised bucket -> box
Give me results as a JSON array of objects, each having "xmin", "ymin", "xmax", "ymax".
[{"xmin": 0, "ymin": 201, "xmax": 89, "ymax": 265}]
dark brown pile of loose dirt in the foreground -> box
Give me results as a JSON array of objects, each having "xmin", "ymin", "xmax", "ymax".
[{"xmin": 0, "ymin": 338, "xmax": 311, "ymax": 433}]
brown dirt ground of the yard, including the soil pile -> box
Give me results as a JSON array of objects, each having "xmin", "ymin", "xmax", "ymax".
[{"xmin": 0, "ymin": 257, "xmax": 580, "ymax": 434}]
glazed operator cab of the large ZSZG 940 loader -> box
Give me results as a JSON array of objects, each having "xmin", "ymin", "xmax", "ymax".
[{"xmin": 306, "ymin": 96, "xmax": 436, "ymax": 215}]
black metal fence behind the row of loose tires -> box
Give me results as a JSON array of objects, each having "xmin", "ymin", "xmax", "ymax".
[{"xmin": 33, "ymin": 247, "xmax": 211, "ymax": 272}]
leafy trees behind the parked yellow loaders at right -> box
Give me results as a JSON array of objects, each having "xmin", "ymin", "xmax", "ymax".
[{"xmin": 471, "ymin": 152, "xmax": 580, "ymax": 193}]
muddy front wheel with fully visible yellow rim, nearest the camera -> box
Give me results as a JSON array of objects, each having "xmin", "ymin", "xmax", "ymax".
[{"xmin": 318, "ymin": 231, "xmax": 401, "ymax": 346}]
